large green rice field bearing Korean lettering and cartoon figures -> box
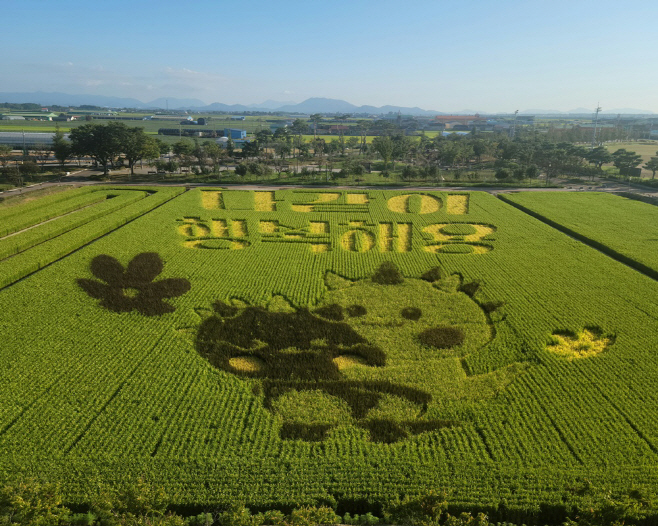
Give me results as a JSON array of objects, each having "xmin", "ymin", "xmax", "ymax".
[{"xmin": 0, "ymin": 187, "xmax": 658, "ymax": 524}]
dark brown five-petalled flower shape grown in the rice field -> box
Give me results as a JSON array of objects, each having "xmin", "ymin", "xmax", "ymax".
[{"xmin": 77, "ymin": 252, "xmax": 190, "ymax": 316}]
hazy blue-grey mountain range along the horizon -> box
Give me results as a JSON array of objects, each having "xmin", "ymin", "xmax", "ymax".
[{"xmin": 0, "ymin": 91, "xmax": 654, "ymax": 116}]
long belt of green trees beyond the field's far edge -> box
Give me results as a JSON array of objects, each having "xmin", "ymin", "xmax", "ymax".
[{"xmin": 0, "ymin": 119, "xmax": 658, "ymax": 186}]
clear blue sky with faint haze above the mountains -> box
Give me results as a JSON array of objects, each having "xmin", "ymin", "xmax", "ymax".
[{"xmin": 0, "ymin": 0, "xmax": 658, "ymax": 113}]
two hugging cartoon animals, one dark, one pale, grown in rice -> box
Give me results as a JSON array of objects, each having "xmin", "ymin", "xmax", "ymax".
[{"xmin": 195, "ymin": 263, "xmax": 502, "ymax": 443}]
